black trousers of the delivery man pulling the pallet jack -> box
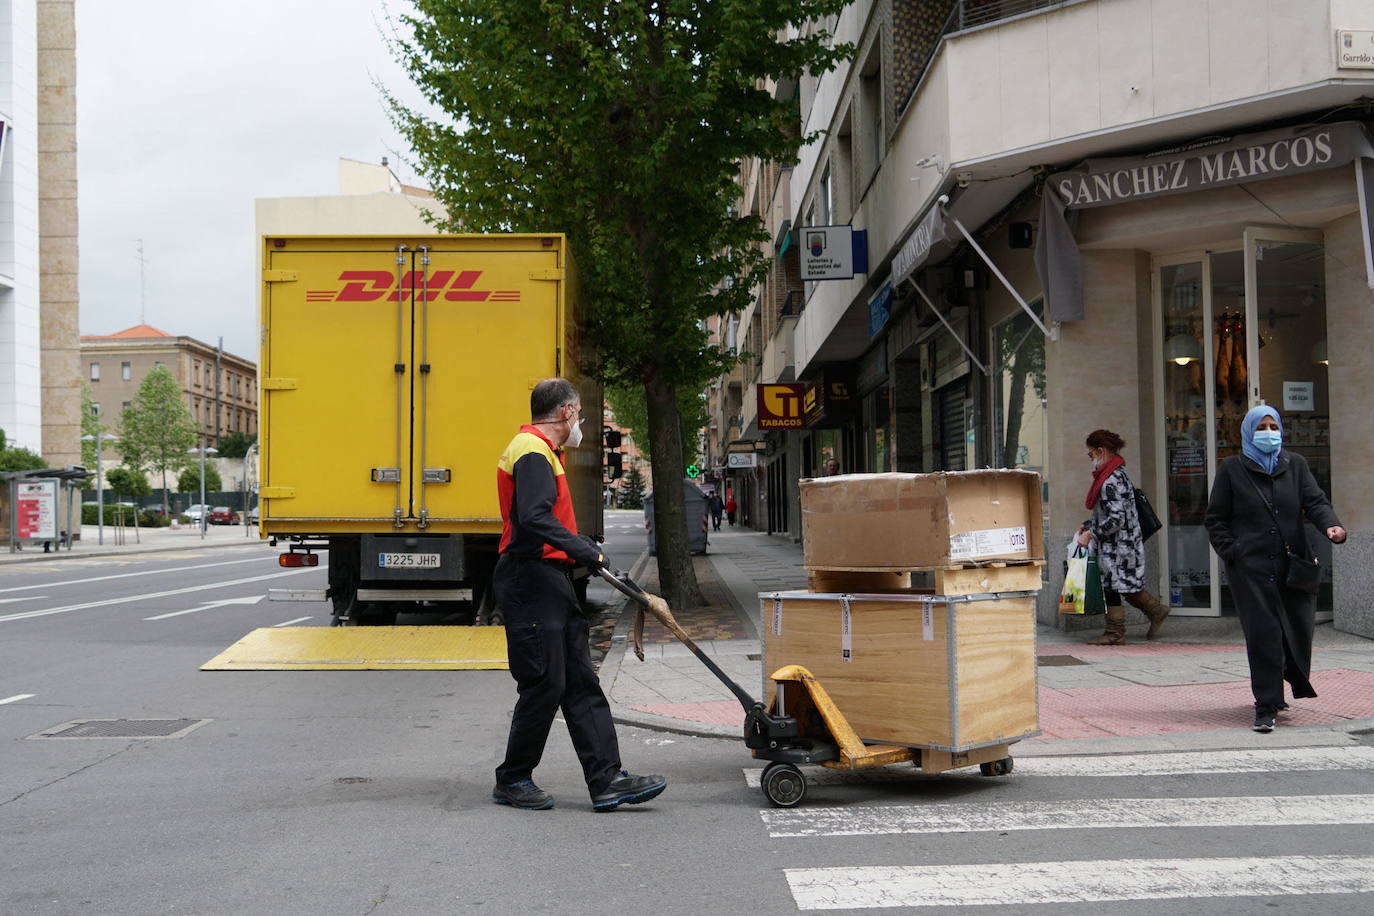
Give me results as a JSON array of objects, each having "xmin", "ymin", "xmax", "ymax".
[{"xmin": 495, "ymin": 553, "xmax": 621, "ymax": 795}]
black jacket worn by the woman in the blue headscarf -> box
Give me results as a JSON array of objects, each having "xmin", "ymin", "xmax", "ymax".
[{"xmin": 1204, "ymin": 452, "xmax": 1341, "ymax": 578}]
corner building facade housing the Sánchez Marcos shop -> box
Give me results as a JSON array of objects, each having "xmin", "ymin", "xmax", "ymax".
[{"xmin": 713, "ymin": 0, "xmax": 1374, "ymax": 636}]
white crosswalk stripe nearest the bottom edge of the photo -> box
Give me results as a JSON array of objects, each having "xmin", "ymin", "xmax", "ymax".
[{"xmin": 786, "ymin": 856, "xmax": 1374, "ymax": 909}]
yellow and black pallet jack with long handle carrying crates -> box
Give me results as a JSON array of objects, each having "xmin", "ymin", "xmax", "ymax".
[{"xmin": 596, "ymin": 567, "xmax": 1013, "ymax": 808}]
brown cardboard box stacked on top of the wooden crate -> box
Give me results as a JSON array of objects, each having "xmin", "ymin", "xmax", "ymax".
[{"xmin": 801, "ymin": 470, "xmax": 1044, "ymax": 570}]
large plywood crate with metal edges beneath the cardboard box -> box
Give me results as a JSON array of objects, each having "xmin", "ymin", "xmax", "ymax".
[{"xmin": 760, "ymin": 592, "xmax": 1039, "ymax": 751}]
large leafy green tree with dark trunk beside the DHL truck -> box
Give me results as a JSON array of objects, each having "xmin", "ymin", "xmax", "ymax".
[{"xmin": 389, "ymin": 0, "xmax": 852, "ymax": 606}]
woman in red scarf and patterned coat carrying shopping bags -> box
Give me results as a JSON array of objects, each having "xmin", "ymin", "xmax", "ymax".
[{"xmin": 1077, "ymin": 430, "xmax": 1169, "ymax": 645}]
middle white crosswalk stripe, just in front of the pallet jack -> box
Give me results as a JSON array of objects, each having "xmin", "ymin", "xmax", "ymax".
[{"xmin": 760, "ymin": 795, "xmax": 1374, "ymax": 839}]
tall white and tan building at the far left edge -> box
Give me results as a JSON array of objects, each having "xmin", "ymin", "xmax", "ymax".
[{"xmin": 0, "ymin": 0, "xmax": 81, "ymax": 467}]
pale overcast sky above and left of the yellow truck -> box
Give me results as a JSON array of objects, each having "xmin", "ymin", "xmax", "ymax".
[{"xmin": 76, "ymin": 0, "xmax": 428, "ymax": 361}]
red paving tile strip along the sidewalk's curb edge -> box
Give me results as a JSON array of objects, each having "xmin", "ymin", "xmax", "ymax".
[{"xmin": 631, "ymin": 667, "xmax": 1374, "ymax": 740}]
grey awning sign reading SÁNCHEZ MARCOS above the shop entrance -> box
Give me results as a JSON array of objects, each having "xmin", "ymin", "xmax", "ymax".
[{"xmin": 1048, "ymin": 122, "xmax": 1370, "ymax": 210}]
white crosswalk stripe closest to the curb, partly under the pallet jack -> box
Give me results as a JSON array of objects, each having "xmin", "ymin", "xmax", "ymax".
[{"xmin": 745, "ymin": 746, "xmax": 1374, "ymax": 788}]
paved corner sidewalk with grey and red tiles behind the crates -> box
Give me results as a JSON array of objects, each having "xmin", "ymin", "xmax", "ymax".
[{"xmin": 600, "ymin": 529, "xmax": 1374, "ymax": 757}]
